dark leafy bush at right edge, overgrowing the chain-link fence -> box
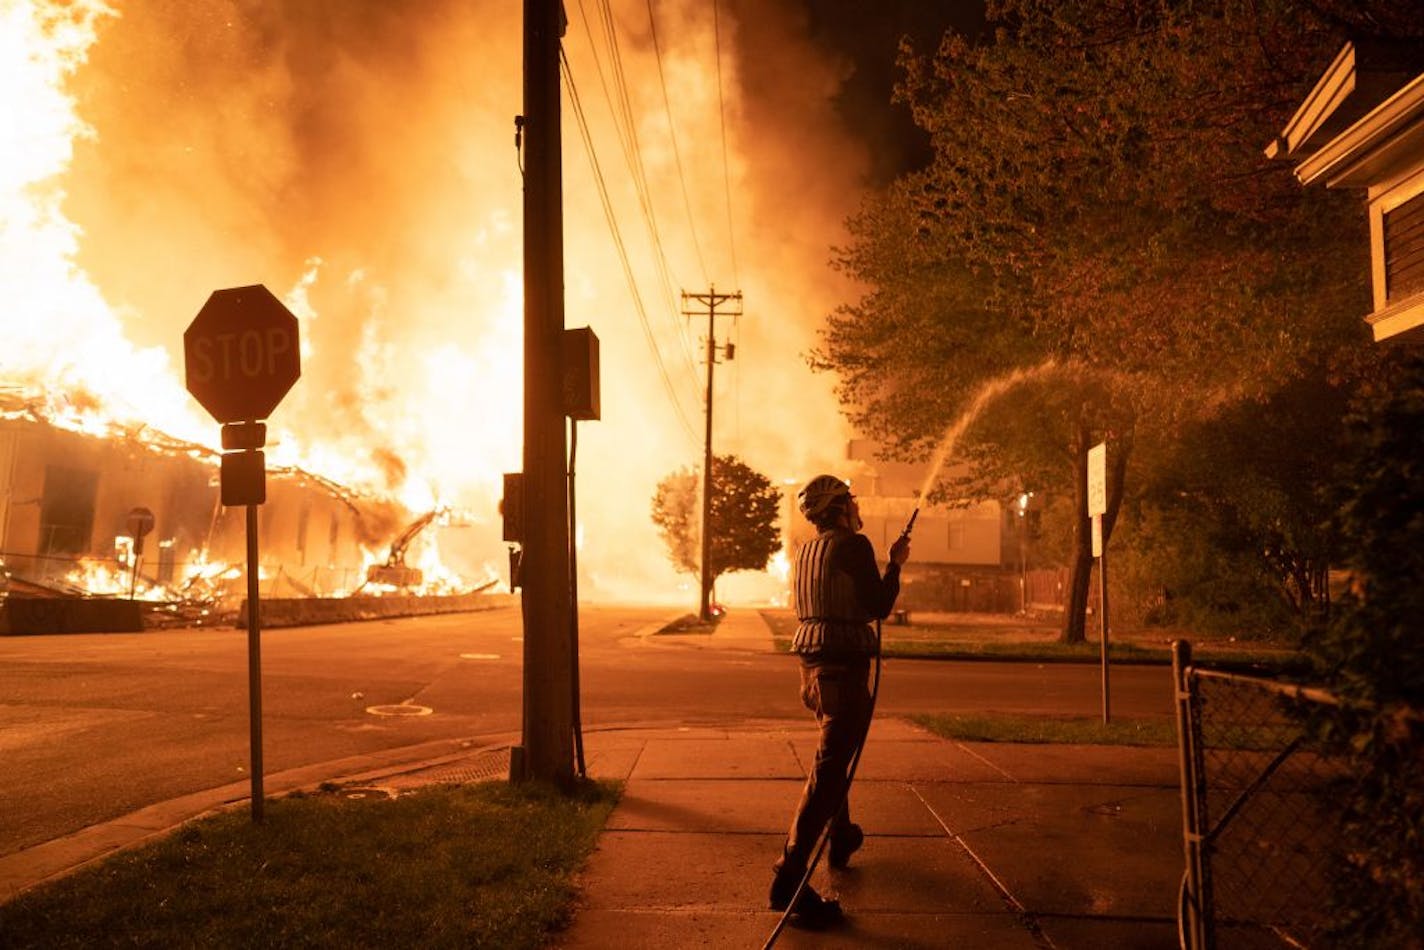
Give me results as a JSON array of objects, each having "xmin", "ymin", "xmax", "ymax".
[{"xmin": 1307, "ymin": 352, "xmax": 1424, "ymax": 947}]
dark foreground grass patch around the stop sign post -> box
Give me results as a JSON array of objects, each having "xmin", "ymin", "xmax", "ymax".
[{"xmin": 0, "ymin": 782, "xmax": 618, "ymax": 949}]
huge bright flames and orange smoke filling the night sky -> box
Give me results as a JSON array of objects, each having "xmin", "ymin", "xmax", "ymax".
[{"xmin": 0, "ymin": 0, "xmax": 863, "ymax": 601}]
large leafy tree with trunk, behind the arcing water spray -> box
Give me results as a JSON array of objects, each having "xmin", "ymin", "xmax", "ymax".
[{"xmin": 813, "ymin": 0, "xmax": 1420, "ymax": 640}]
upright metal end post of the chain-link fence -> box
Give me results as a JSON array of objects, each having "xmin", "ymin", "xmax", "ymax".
[{"xmin": 1172, "ymin": 640, "xmax": 1216, "ymax": 950}]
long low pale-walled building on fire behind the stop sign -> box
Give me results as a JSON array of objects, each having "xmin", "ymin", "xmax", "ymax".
[{"xmin": 0, "ymin": 406, "xmax": 407, "ymax": 618}]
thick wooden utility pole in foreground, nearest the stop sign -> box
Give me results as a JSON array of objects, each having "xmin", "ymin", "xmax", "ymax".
[{"xmin": 521, "ymin": 0, "xmax": 574, "ymax": 788}]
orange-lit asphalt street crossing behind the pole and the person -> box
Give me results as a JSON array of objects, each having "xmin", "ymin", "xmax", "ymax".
[{"xmin": 0, "ymin": 607, "xmax": 1172, "ymax": 855}]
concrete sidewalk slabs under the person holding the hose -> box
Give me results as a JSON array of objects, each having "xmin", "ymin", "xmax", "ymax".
[{"xmin": 555, "ymin": 718, "xmax": 1182, "ymax": 950}]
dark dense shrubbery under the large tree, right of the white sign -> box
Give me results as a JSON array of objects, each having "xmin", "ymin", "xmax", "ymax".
[{"xmin": 1114, "ymin": 375, "xmax": 1349, "ymax": 637}]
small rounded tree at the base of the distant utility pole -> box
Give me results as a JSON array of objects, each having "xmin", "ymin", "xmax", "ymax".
[{"xmin": 652, "ymin": 456, "xmax": 782, "ymax": 601}]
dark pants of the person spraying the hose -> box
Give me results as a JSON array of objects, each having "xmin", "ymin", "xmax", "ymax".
[{"xmin": 776, "ymin": 657, "xmax": 870, "ymax": 873}]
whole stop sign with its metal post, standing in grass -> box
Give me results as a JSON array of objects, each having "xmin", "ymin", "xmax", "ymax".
[{"xmin": 182, "ymin": 283, "xmax": 302, "ymax": 822}]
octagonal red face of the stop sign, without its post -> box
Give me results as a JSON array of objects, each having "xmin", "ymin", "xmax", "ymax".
[{"xmin": 182, "ymin": 283, "xmax": 302, "ymax": 423}]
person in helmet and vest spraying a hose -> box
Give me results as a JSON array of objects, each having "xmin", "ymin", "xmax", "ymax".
[{"xmin": 770, "ymin": 474, "xmax": 910, "ymax": 927}]
